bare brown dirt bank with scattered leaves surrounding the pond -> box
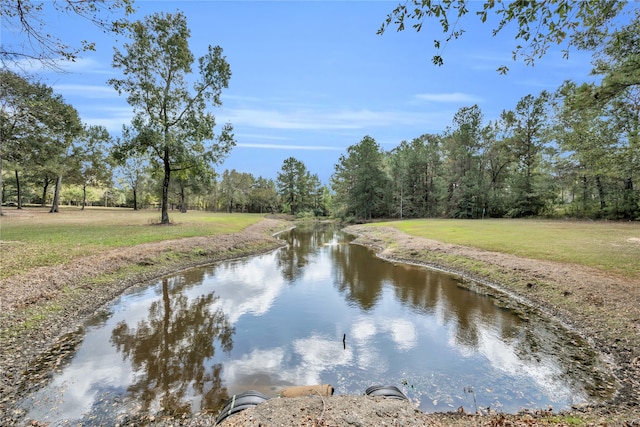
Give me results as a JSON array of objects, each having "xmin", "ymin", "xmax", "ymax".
[{"xmin": 0, "ymin": 219, "xmax": 640, "ymax": 427}]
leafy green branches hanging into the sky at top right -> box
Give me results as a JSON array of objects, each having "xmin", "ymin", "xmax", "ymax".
[{"xmin": 378, "ymin": 0, "xmax": 626, "ymax": 73}]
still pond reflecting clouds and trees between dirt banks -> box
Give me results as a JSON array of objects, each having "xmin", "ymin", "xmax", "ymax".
[{"xmin": 21, "ymin": 226, "xmax": 612, "ymax": 425}]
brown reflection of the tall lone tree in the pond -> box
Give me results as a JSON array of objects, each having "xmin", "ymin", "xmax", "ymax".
[{"xmin": 111, "ymin": 277, "xmax": 235, "ymax": 414}]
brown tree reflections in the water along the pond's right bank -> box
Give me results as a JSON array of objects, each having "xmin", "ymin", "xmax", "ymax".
[{"xmin": 328, "ymin": 230, "xmax": 612, "ymax": 397}]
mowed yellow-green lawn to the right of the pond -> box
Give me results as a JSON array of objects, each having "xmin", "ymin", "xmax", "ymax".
[{"xmin": 375, "ymin": 219, "xmax": 640, "ymax": 279}]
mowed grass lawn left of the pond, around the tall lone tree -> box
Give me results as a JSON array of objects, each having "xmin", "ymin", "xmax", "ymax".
[{"xmin": 0, "ymin": 207, "xmax": 264, "ymax": 279}]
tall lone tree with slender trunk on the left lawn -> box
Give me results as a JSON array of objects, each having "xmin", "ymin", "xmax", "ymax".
[{"xmin": 109, "ymin": 12, "xmax": 235, "ymax": 224}]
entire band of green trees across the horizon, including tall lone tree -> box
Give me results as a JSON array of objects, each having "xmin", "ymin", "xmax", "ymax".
[{"xmin": 0, "ymin": 6, "xmax": 640, "ymax": 223}]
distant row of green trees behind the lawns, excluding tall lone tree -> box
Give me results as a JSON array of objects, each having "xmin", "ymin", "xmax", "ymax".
[{"xmin": 2, "ymin": 89, "xmax": 640, "ymax": 220}]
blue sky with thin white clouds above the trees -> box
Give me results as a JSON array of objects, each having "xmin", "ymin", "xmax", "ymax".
[{"xmin": 2, "ymin": 0, "xmax": 637, "ymax": 184}]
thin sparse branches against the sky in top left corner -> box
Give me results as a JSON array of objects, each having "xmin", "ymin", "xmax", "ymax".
[{"xmin": 0, "ymin": 0, "xmax": 134, "ymax": 69}]
